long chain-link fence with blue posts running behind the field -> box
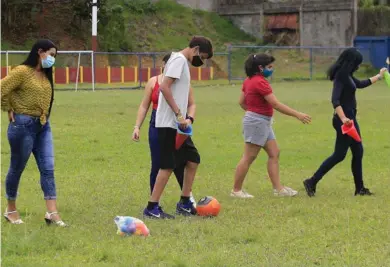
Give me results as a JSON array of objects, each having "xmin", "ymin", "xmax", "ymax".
[{"xmin": 1, "ymin": 45, "xmax": 373, "ymax": 91}]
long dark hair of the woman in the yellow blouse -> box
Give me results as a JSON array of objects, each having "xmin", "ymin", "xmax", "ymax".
[{"xmin": 22, "ymin": 39, "xmax": 58, "ymax": 115}]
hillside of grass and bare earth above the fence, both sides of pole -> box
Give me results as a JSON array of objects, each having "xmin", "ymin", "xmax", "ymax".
[{"xmin": 1, "ymin": 0, "xmax": 258, "ymax": 52}]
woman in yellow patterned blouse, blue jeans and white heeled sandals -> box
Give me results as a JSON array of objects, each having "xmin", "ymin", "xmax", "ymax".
[{"xmin": 1, "ymin": 40, "xmax": 66, "ymax": 226}]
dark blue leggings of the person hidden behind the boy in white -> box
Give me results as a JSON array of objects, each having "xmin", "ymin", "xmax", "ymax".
[{"xmin": 149, "ymin": 109, "xmax": 186, "ymax": 195}]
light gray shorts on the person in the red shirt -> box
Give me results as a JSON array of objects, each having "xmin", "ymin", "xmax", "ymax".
[{"xmin": 242, "ymin": 111, "xmax": 276, "ymax": 147}]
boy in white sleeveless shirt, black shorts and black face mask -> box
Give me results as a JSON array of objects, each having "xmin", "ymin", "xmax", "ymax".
[{"xmin": 144, "ymin": 37, "xmax": 213, "ymax": 219}]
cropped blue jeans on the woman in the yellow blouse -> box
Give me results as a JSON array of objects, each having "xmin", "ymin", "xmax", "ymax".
[{"xmin": 5, "ymin": 114, "xmax": 56, "ymax": 200}]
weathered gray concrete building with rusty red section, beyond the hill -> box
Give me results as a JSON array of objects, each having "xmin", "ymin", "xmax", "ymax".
[{"xmin": 176, "ymin": 0, "xmax": 358, "ymax": 46}]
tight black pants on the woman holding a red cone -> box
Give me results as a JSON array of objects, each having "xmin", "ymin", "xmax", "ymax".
[{"xmin": 311, "ymin": 111, "xmax": 364, "ymax": 191}]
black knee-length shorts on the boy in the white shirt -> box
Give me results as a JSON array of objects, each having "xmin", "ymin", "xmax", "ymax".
[{"xmin": 157, "ymin": 128, "xmax": 200, "ymax": 170}]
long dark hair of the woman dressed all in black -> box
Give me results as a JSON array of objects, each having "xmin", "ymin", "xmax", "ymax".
[{"xmin": 327, "ymin": 47, "xmax": 363, "ymax": 81}]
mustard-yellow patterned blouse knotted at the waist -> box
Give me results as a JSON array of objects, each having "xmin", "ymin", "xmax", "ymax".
[{"xmin": 0, "ymin": 65, "xmax": 53, "ymax": 125}]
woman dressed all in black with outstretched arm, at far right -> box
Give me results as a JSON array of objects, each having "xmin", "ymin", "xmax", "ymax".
[{"xmin": 303, "ymin": 48, "xmax": 387, "ymax": 197}]
